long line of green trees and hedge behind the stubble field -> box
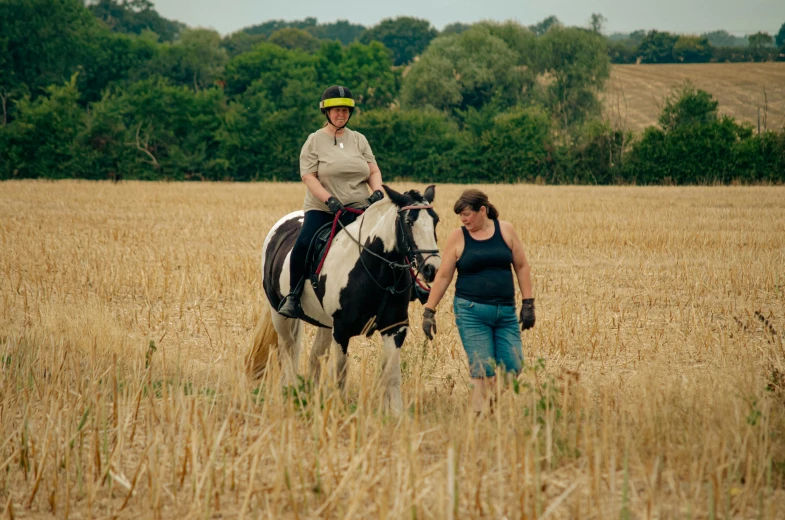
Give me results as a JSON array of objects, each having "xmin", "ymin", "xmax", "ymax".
[{"xmin": 0, "ymin": 0, "xmax": 785, "ymax": 184}]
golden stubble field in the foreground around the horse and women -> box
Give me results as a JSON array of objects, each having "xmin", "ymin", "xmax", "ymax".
[{"xmin": 0, "ymin": 182, "xmax": 785, "ymax": 519}]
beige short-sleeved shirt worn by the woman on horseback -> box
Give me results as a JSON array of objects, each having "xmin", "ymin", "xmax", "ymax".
[{"xmin": 300, "ymin": 128, "xmax": 376, "ymax": 211}]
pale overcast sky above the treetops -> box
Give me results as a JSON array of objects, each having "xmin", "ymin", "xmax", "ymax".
[{"xmin": 153, "ymin": 0, "xmax": 785, "ymax": 36}]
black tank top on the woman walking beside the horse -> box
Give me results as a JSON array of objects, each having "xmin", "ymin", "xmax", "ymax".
[{"xmin": 455, "ymin": 219, "xmax": 515, "ymax": 306}]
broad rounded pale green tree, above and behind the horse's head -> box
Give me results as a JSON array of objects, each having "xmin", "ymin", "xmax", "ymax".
[{"xmin": 401, "ymin": 27, "xmax": 527, "ymax": 110}]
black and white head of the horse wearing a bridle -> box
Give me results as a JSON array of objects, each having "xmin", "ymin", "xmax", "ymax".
[{"xmin": 384, "ymin": 185, "xmax": 442, "ymax": 282}]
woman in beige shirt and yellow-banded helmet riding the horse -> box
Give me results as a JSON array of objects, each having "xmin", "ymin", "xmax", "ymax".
[{"xmin": 278, "ymin": 85, "xmax": 384, "ymax": 318}]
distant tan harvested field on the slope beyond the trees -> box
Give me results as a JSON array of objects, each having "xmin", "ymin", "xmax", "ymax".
[{"xmin": 606, "ymin": 63, "xmax": 785, "ymax": 131}]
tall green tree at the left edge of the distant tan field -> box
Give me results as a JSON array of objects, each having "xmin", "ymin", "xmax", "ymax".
[{"xmin": 538, "ymin": 27, "xmax": 610, "ymax": 127}]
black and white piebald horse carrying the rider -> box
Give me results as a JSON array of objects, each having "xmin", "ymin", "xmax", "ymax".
[{"xmin": 246, "ymin": 186, "xmax": 441, "ymax": 414}]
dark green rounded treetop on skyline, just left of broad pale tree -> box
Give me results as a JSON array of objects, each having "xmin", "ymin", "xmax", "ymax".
[{"xmin": 360, "ymin": 16, "xmax": 438, "ymax": 65}]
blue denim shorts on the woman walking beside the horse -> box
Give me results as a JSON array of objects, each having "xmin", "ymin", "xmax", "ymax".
[{"xmin": 453, "ymin": 296, "xmax": 523, "ymax": 379}]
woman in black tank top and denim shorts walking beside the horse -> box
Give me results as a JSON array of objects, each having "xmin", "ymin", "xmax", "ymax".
[{"xmin": 422, "ymin": 190, "xmax": 535, "ymax": 413}]
